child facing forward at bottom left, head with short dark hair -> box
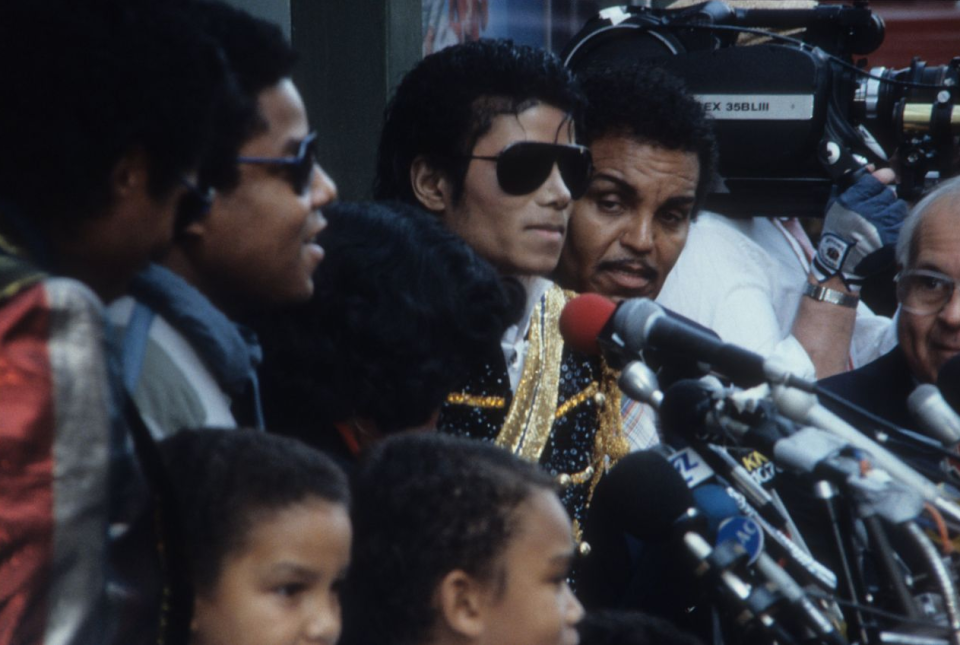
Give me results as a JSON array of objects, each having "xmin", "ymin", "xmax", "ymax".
[{"xmin": 162, "ymin": 430, "xmax": 351, "ymax": 645}]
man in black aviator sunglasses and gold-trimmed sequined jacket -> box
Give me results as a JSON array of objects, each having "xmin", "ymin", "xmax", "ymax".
[{"xmin": 374, "ymin": 41, "xmax": 626, "ymax": 536}]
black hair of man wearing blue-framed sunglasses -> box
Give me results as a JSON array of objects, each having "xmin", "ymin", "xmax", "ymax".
[{"xmin": 186, "ymin": 0, "xmax": 297, "ymax": 191}]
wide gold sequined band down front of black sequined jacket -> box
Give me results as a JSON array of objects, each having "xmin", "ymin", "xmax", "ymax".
[{"xmin": 497, "ymin": 286, "xmax": 567, "ymax": 462}]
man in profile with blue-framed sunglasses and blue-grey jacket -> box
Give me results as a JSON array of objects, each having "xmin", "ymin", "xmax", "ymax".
[{"xmin": 110, "ymin": 2, "xmax": 336, "ymax": 437}]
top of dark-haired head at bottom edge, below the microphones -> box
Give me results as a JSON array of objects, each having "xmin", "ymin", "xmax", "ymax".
[{"xmin": 577, "ymin": 610, "xmax": 701, "ymax": 645}]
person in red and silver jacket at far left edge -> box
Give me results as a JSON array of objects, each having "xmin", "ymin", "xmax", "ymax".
[{"xmin": 0, "ymin": 0, "xmax": 228, "ymax": 645}]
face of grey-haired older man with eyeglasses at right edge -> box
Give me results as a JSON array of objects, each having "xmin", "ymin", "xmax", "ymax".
[{"xmin": 897, "ymin": 199, "xmax": 960, "ymax": 383}]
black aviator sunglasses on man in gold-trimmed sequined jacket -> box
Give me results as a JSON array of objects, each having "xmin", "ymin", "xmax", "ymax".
[{"xmin": 467, "ymin": 141, "xmax": 593, "ymax": 199}]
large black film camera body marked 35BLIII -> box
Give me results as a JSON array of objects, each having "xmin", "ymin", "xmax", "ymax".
[{"xmin": 562, "ymin": 0, "xmax": 960, "ymax": 217}]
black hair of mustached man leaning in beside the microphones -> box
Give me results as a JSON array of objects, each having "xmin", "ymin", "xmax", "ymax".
[{"xmin": 577, "ymin": 65, "xmax": 717, "ymax": 214}]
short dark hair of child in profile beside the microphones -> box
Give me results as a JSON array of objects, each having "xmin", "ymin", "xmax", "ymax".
[{"xmin": 341, "ymin": 434, "xmax": 555, "ymax": 645}]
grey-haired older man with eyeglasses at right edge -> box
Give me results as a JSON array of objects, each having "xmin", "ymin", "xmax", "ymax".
[{"xmin": 820, "ymin": 178, "xmax": 960, "ymax": 472}]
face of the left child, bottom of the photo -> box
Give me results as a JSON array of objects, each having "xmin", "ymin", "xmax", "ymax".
[{"xmin": 192, "ymin": 498, "xmax": 351, "ymax": 645}]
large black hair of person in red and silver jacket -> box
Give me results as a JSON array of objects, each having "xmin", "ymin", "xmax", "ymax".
[{"xmin": 0, "ymin": 0, "xmax": 229, "ymax": 230}]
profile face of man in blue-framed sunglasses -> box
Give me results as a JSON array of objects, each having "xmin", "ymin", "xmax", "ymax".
[{"xmin": 187, "ymin": 79, "xmax": 337, "ymax": 313}]
